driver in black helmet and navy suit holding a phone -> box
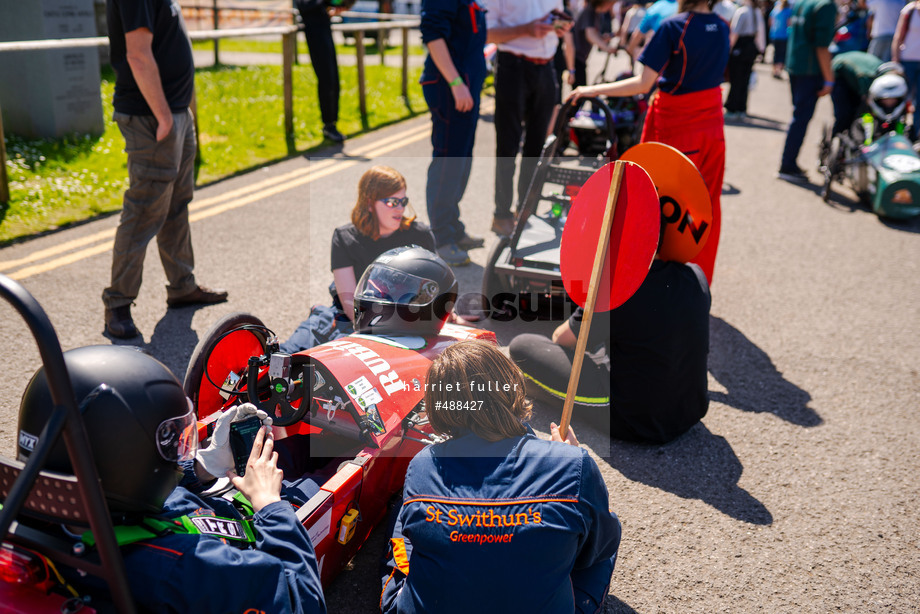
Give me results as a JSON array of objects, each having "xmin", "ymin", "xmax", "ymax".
[{"xmin": 18, "ymin": 346, "xmax": 326, "ymax": 614}]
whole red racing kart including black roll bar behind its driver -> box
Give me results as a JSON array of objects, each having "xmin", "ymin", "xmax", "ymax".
[{"xmin": 0, "ymin": 275, "xmax": 495, "ymax": 614}]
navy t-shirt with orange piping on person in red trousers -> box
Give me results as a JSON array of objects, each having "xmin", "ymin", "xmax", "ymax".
[{"xmin": 639, "ymin": 12, "xmax": 729, "ymax": 95}]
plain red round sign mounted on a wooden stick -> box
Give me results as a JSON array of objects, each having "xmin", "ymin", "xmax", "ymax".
[{"xmin": 559, "ymin": 162, "xmax": 660, "ymax": 311}]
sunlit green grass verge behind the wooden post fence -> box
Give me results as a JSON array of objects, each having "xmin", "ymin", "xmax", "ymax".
[{"xmin": 0, "ymin": 65, "xmax": 427, "ymax": 245}]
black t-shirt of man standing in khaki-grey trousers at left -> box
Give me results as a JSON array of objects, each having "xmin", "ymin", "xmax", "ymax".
[{"xmin": 106, "ymin": 0, "xmax": 195, "ymax": 115}]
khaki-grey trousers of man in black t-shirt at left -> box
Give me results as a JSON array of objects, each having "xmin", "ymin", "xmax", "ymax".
[{"xmin": 102, "ymin": 110, "xmax": 197, "ymax": 309}]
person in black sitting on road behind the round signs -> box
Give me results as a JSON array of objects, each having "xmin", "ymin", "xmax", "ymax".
[{"xmin": 508, "ymin": 219, "xmax": 712, "ymax": 443}]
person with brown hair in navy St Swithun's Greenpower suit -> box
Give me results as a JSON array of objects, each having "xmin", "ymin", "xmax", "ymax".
[{"xmin": 380, "ymin": 341, "xmax": 621, "ymax": 614}]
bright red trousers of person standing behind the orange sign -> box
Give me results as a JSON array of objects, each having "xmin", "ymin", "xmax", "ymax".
[{"xmin": 642, "ymin": 87, "xmax": 725, "ymax": 285}]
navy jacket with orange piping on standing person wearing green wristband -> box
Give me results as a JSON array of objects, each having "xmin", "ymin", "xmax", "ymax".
[{"xmin": 419, "ymin": 0, "xmax": 486, "ymax": 92}]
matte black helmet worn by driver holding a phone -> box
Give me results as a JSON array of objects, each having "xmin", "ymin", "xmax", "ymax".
[{"xmin": 17, "ymin": 345, "xmax": 198, "ymax": 514}]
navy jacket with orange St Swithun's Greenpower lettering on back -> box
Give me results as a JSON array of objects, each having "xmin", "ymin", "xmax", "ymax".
[{"xmin": 381, "ymin": 434, "xmax": 620, "ymax": 614}]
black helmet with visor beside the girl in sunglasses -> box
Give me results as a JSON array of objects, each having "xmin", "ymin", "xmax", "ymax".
[{"xmin": 355, "ymin": 245, "xmax": 457, "ymax": 335}]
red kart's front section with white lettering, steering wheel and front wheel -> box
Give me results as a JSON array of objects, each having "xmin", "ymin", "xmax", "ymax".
[{"xmin": 184, "ymin": 314, "xmax": 495, "ymax": 585}]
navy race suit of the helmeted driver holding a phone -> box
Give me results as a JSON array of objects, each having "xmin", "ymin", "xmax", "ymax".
[{"xmin": 115, "ymin": 470, "xmax": 326, "ymax": 614}]
